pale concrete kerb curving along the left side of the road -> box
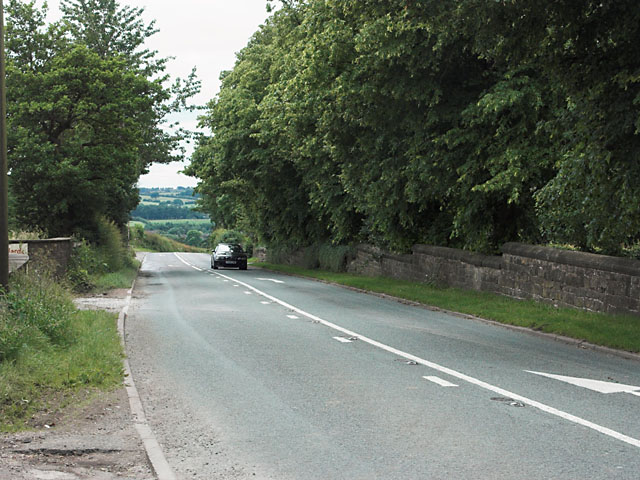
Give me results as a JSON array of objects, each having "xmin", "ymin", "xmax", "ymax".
[{"xmin": 118, "ymin": 259, "xmax": 177, "ymax": 480}]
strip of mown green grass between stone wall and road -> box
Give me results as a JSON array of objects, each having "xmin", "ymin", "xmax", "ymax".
[{"xmin": 253, "ymin": 263, "xmax": 640, "ymax": 353}]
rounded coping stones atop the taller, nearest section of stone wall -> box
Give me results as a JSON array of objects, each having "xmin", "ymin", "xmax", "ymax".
[{"xmin": 502, "ymin": 242, "xmax": 640, "ymax": 277}]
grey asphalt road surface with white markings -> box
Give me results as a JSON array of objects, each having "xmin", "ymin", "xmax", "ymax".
[{"xmin": 126, "ymin": 254, "xmax": 640, "ymax": 480}]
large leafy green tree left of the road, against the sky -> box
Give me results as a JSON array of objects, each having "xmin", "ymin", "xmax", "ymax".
[{"xmin": 7, "ymin": 0, "xmax": 197, "ymax": 238}]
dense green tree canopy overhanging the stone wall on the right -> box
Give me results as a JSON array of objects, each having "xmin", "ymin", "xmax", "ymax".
[{"xmin": 189, "ymin": 0, "xmax": 640, "ymax": 252}]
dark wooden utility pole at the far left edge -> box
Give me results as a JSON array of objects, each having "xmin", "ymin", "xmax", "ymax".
[{"xmin": 0, "ymin": 0, "xmax": 9, "ymax": 292}]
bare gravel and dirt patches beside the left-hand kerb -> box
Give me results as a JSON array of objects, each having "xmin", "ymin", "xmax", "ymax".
[{"xmin": 0, "ymin": 290, "xmax": 154, "ymax": 480}]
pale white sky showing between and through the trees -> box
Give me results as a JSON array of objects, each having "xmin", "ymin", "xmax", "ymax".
[{"xmin": 38, "ymin": 0, "xmax": 268, "ymax": 187}]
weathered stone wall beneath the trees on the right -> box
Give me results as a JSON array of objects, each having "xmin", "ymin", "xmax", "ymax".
[{"xmin": 348, "ymin": 243, "xmax": 640, "ymax": 315}]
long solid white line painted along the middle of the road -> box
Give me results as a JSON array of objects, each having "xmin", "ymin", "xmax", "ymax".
[{"xmin": 174, "ymin": 253, "xmax": 640, "ymax": 448}]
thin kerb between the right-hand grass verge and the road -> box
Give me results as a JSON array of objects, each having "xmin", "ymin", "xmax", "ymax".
[{"xmin": 254, "ymin": 266, "xmax": 640, "ymax": 362}]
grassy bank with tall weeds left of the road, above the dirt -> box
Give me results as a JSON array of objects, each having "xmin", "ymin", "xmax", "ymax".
[{"xmin": 0, "ymin": 275, "xmax": 124, "ymax": 432}]
